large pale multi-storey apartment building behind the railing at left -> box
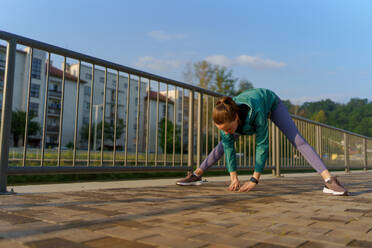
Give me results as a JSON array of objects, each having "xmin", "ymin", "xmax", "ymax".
[{"xmin": 0, "ymin": 46, "xmax": 147, "ymax": 152}]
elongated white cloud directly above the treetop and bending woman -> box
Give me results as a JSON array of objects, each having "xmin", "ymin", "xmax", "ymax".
[{"xmin": 206, "ymin": 54, "xmax": 287, "ymax": 68}]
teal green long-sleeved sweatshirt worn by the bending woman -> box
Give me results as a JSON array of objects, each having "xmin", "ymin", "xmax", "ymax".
[{"xmin": 220, "ymin": 89, "xmax": 279, "ymax": 173}]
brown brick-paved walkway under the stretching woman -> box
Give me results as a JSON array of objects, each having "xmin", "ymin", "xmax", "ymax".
[{"xmin": 0, "ymin": 172, "xmax": 372, "ymax": 248}]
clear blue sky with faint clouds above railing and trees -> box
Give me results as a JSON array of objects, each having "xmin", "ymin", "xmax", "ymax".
[{"xmin": 0, "ymin": 0, "xmax": 372, "ymax": 103}]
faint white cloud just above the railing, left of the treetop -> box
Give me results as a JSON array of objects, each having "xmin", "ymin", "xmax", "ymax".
[{"xmin": 136, "ymin": 56, "xmax": 181, "ymax": 72}]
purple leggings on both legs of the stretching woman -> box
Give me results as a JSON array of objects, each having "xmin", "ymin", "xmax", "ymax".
[{"xmin": 199, "ymin": 101, "xmax": 327, "ymax": 173}]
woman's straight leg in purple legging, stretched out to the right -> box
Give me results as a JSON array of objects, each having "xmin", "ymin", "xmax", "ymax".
[{"xmin": 270, "ymin": 101, "xmax": 329, "ymax": 173}]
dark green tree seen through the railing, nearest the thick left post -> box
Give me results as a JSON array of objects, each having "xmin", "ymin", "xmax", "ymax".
[{"xmin": 11, "ymin": 110, "xmax": 40, "ymax": 146}]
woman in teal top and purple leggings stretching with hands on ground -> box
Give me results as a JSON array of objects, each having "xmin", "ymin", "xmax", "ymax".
[{"xmin": 177, "ymin": 89, "xmax": 347, "ymax": 195}]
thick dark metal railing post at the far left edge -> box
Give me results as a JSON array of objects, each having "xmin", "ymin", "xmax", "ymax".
[{"xmin": 0, "ymin": 40, "xmax": 17, "ymax": 194}]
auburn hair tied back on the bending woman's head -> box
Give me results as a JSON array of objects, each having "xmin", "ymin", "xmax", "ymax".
[{"xmin": 212, "ymin": 96, "xmax": 238, "ymax": 125}]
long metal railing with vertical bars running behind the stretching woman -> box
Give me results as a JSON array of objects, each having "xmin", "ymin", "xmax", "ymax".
[{"xmin": 0, "ymin": 31, "xmax": 372, "ymax": 192}]
